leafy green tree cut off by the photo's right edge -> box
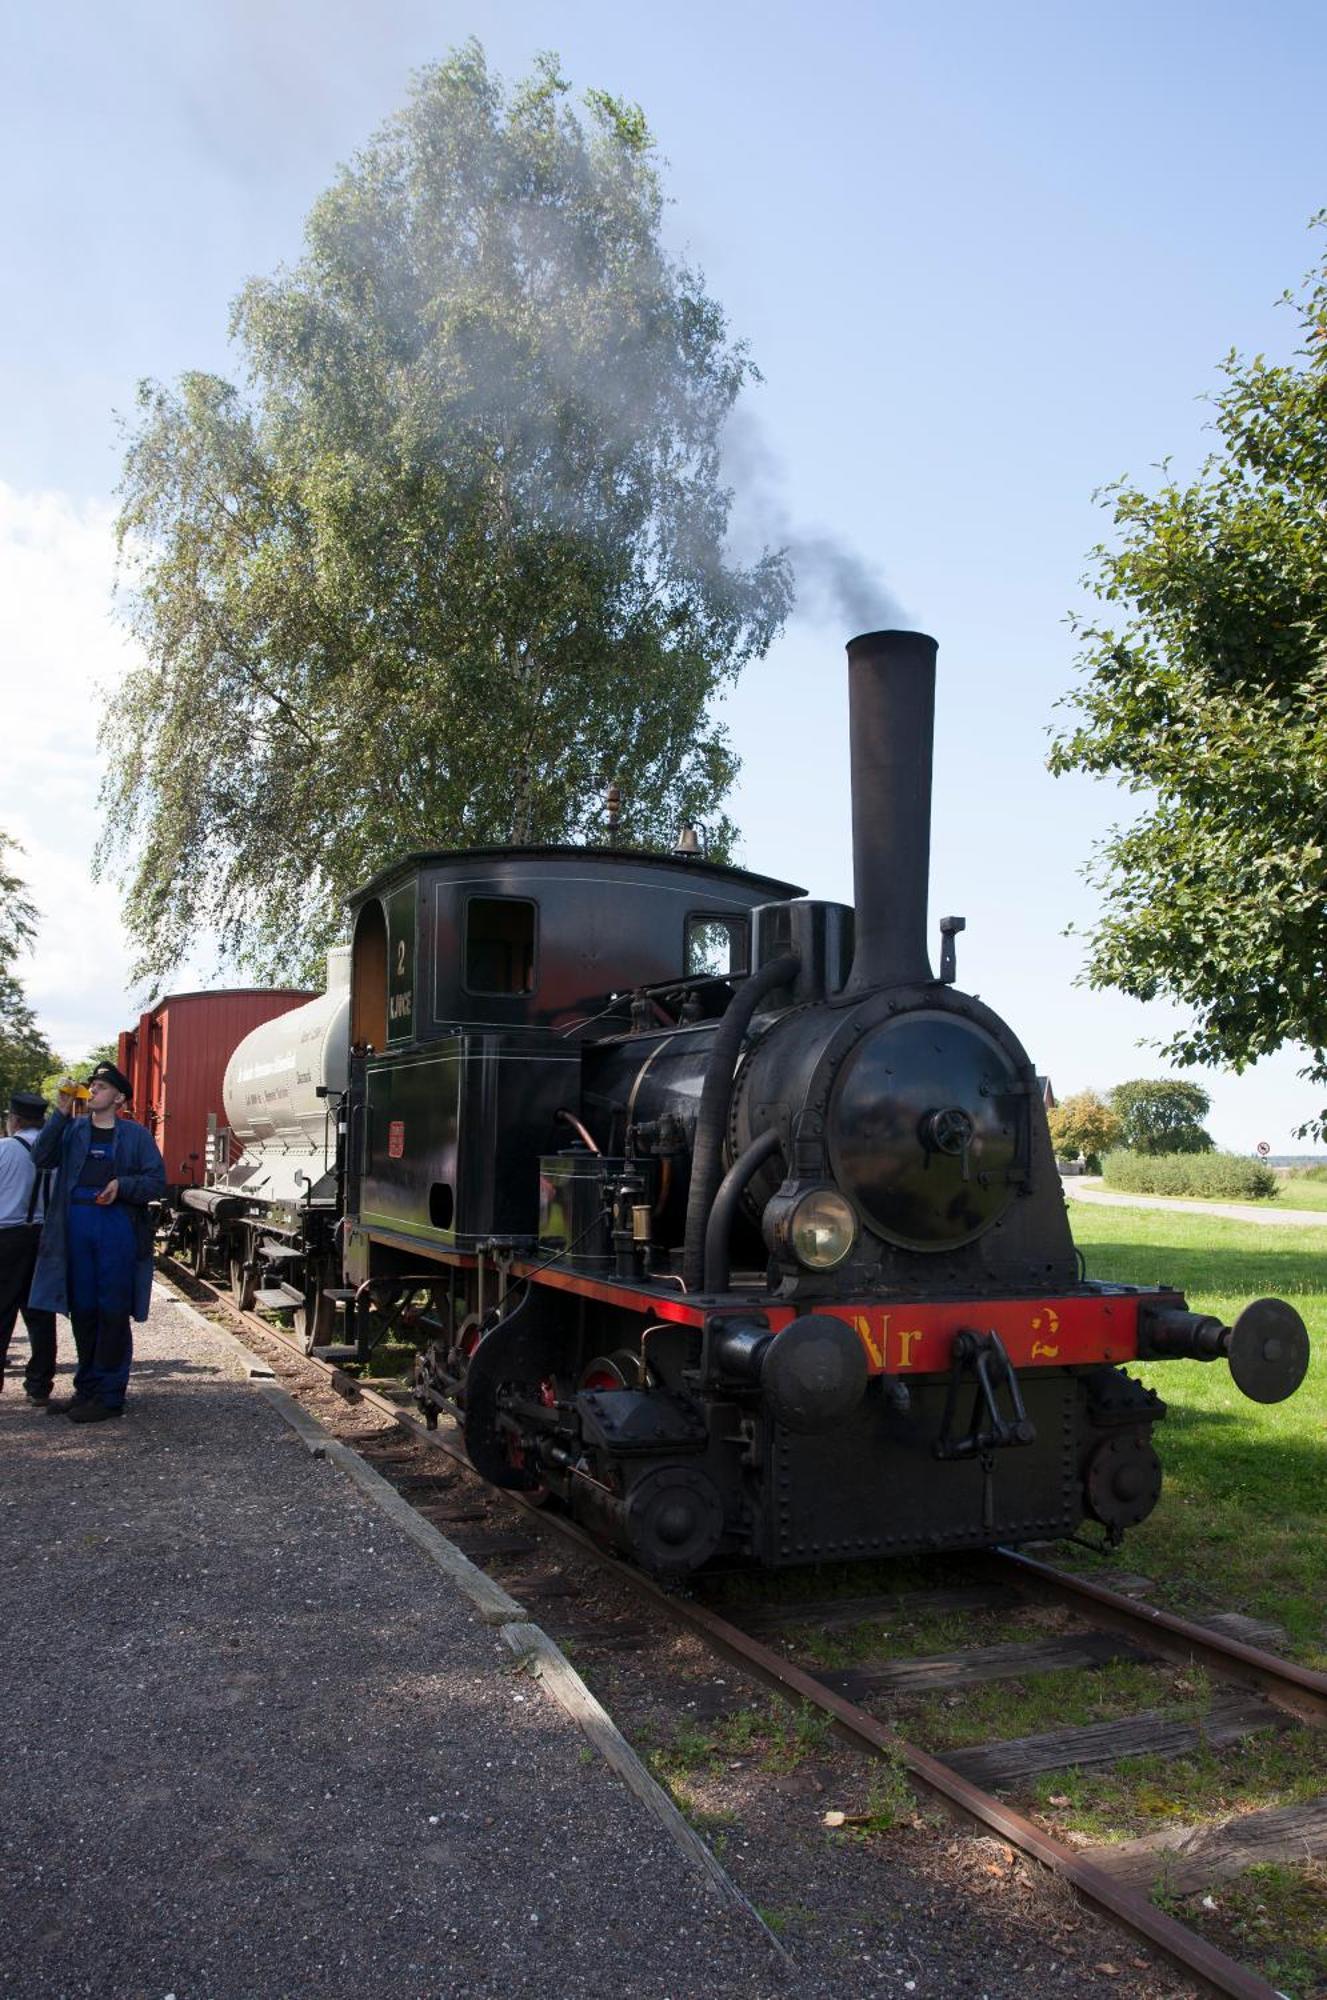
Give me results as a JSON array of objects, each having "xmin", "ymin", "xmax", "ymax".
[{"xmin": 1051, "ymin": 216, "xmax": 1327, "ymax": 1134}]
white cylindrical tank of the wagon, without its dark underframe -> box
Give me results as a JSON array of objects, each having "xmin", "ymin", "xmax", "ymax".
[{"xmin": 218, "ymin": 946, "xmax": 350, "ymax": 1202}]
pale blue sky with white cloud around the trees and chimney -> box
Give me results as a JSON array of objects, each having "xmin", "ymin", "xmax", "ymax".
[{"xmin": 0, "ymin": 0, "xmax": 1327, "ymax": 1150}]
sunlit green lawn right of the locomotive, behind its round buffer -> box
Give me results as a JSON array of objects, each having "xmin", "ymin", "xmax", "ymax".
[{"xmin": 1069, "ymin": 1182, "xmax": 1327, "ymax": 1668}]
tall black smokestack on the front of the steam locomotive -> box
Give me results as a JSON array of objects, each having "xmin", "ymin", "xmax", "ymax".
[{"xmin": 845, "ymin": 632, "xmax": 935, "ymax": 992}]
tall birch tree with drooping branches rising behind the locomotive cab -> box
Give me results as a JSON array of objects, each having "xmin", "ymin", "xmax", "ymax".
[{"xmin": 100, "ymin": 44, "xmax": 791, "ymax": 976}]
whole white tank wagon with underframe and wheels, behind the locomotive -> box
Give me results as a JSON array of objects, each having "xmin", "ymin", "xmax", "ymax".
[{"xmin": 180, "ymin": 948, "xmax": 350, "ymax": 1346}]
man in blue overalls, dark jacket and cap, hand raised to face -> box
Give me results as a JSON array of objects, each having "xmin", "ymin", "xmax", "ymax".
[{"xmin": 30, "ymin": 1062, "xmax": 166, "ymax": 1424}]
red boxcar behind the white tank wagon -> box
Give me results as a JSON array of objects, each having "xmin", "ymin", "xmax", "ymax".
[{"xmin": 116, "ymin": 986, "xmax": 318, "ymax": 1184}]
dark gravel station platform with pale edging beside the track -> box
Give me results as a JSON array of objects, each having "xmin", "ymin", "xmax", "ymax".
[{"xmin": 0, "ymin": 1300, "xmax": 791, "ymax": 2000}]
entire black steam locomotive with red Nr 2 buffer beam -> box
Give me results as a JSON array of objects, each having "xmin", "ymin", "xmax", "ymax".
[{"xmin": 330, "ymin": 632, "xmax": 1309, "ymax": 1572}]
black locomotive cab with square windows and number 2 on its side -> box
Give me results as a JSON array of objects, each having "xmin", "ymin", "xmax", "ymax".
[{"xmin": 343, "ymin": 848, "xmax": 797, "ymax": 1274}]
